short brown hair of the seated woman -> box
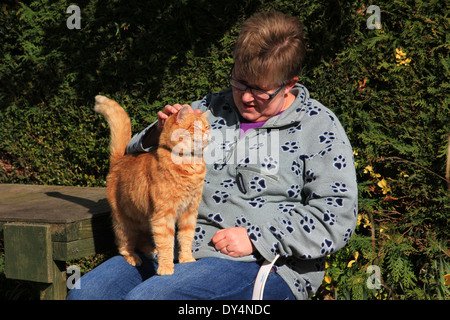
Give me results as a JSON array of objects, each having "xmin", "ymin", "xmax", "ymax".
[{"xmin": 233, "ymin": 12, "xmax": 306, "ymax": 84}]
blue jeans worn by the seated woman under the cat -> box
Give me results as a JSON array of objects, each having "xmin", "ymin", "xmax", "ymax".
[{"xmin": 67, "ymin": 256, "xmax": 295, "ymax": 300}]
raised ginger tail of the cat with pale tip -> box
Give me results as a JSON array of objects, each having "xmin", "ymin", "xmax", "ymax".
[{"xmin": 94, "ymin": 96, "xmax": 131, "ymax": 164}]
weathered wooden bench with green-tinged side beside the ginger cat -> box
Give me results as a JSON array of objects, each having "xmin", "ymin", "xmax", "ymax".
[{"xmin": 0, "ymin": 184, "xmax": 114, "ymax": 300}]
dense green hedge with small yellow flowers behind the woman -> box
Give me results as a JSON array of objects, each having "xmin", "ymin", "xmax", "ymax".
[{"xmin": 0, "ymin": 0, "xmax": 450, "ymax": 299}]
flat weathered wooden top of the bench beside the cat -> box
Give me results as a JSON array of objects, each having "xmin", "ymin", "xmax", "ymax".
[{"xmin": 0, "ymin": 184, "xmax": 110, "ymax": 224}]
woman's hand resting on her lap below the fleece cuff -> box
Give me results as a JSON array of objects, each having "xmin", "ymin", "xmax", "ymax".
[{"xmin": 211, "ymin": 227, "xmax": 256, "ymax": 258}]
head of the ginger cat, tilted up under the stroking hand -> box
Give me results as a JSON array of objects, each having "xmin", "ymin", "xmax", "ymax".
[{"xmin": 159, "ymin": 106, "xmax": 210, "ymax": 158}]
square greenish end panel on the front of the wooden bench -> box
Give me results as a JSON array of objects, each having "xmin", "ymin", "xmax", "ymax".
[{"xmin": 3, "ymin": 223, "xmax": 53, "ymax": 283}]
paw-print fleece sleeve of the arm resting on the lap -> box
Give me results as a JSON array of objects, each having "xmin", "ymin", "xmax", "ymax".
[{"xmin": 253, "ymin": 112, "xmax": 358, "ymax": 260}]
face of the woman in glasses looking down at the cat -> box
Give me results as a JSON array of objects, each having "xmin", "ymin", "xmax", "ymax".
[{"xmin": 232, "ymin": 68, "xmax": 298, "ymax": 122}]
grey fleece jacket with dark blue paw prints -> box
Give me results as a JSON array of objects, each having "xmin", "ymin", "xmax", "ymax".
[{"xmin": 127, "ymin": 84, "xmax": 358, "ymax": 299}]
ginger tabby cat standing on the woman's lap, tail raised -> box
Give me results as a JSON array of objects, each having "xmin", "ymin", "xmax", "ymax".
[{"xmin": 94, "ymin": 96, "xmax": 209, "ymax": 275}]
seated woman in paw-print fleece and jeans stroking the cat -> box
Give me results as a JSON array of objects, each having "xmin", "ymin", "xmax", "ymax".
[{"xmin": 69, "ymin": 12, "xmax": 358, "ymax": 299}]
